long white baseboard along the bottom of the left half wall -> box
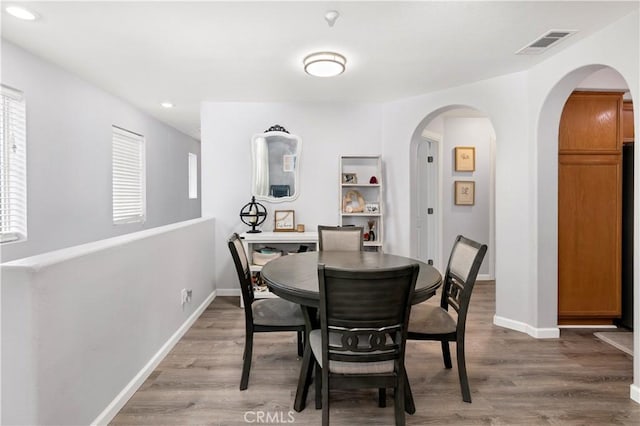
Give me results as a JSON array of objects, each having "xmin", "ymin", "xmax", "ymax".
[{"xmin": 91, "ymin": 290, "xmax": 217, "ymax": 426}]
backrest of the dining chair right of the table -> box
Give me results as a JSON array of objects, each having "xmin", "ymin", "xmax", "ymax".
[{"xmin": 440, "ymin": 235, "xmax": 487, "ymax": 332}]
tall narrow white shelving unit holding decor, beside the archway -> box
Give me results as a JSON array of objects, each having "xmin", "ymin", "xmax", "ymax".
[{"xmin": 338, "ymin": 155, "xmax": 384, "ymax": 251}]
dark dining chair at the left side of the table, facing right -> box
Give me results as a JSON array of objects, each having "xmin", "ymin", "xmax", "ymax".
[{"xmin": 227, "ymin": 233, "xmax": 305, "ymax": 390}]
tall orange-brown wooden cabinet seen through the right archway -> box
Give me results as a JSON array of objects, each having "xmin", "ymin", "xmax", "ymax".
[{"xmin": 558, "ymin": 92, "xmax": 622, "ymax": 324}]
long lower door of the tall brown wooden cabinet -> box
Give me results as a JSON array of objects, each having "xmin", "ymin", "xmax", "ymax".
[{"xmin": 558, "ymin": 155, "xmax": 622, "ymax": 323}]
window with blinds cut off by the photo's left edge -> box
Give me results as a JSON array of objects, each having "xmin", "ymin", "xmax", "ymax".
[{"xmin": 0, "ymin": 86, "xmax": 27, "ymax": 243}]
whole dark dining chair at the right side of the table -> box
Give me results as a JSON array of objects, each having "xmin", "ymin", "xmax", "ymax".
[{"xmin": 408, "ymin": 235, "xmax": 487, "ymax": 402}]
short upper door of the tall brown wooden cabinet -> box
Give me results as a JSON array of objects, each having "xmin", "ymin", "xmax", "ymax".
[{"xmin": 558, "ymin": 92, "xmax": 622, "ymax": 154}]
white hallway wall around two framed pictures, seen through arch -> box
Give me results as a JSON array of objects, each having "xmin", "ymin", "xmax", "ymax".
[{"xmin": 440, "ymin": 117, "xmax": 493, "ymax": 275}]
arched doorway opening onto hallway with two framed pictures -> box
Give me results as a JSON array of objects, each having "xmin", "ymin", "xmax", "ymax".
[{"xmin": 410, "ymin": 105, "xmax": 496, "ymax": 279}]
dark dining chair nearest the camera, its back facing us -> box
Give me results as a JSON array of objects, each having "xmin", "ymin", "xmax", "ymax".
[{"xmin": 309, "ymin": 264, "xmax": 419, "ymax": 426}]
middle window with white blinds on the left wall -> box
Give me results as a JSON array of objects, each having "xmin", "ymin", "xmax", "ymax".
[{"xmin": 112, "ymin": 126, "xmax": 146, "ymax": 224}]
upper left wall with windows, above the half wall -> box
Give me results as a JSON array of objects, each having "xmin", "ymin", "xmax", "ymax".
[{"xmin": 2, "ymin": 40, "xmax": 200, "ymax": 261}]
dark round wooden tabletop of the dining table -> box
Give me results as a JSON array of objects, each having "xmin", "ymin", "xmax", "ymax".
[{"xmin": 261, "ymin": 251, "xmax": 442, "ymax": 308}]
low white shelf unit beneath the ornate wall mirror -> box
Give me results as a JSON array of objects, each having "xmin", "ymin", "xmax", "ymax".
[{"xmin": 240, "ymin": 232, "xmax": 318, "ymax": 306}]
